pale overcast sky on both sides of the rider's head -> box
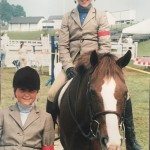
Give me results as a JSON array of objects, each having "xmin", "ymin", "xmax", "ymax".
[{"xmin": 7, "ymin": 0, "xmax": 150, "ymax": 20}]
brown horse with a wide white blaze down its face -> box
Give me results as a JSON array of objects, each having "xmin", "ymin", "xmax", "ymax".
[{"xmin": 55, "ymin": 51, "xmax": 131, "ymax": 150}]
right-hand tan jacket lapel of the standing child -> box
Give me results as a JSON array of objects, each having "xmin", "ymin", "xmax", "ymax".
[{"xmin": 23, "ymin": 107, "xmax": 39, "ymax": 130}]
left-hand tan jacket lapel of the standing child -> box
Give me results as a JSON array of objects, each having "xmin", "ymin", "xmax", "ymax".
[{"xmin": 9, "ymin": 104, "xmax": 22, "ymax": 129}]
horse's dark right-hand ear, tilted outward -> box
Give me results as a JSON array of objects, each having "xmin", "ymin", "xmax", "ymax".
[{"xmin": 116, "ymin": 50, "xmax": 132, "ymax": 68}]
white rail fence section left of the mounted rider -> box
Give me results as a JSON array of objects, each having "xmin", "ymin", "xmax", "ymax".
[{"xmin": 1, "ymin": 36, "xmax": 58, "ymax": 67}]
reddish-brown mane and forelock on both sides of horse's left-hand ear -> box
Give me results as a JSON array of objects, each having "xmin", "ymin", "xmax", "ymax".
[{"xmin": 76, "ymin": 52, "xmax": 123, "ymax": 79}]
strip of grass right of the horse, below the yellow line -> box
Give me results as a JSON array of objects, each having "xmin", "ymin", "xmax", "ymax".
[{"xmin": 126, "ymin": 70, "xmax": 150, "ymax": 150}]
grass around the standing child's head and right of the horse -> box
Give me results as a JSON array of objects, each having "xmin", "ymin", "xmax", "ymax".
[{"xmin": 0, "ymin": 68, "xmax": 150, "ymax": 150}]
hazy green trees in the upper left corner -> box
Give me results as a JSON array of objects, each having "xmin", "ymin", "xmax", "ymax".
[{"xmin": 0, "ymin": 0, "xmax": 26, "ymax": 22}]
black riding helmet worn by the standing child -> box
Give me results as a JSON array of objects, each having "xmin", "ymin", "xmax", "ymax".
[{"xmin": 13, "ymin": 66, "xmax": 40, "ymax": 91}]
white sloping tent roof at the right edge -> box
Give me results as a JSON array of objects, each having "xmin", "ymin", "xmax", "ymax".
[{"xmin": 122, "ymin": 19, "xmax": 150, "ymax": 34}]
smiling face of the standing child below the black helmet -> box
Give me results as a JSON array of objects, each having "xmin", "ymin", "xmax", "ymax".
[{"xmin": 15, "ymin": 88, "xmax": 38, "ymax": 105}]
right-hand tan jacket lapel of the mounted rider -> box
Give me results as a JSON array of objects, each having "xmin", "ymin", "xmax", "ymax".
[{"xmin": 82, "ymin": 7, "xmax": 96, "ymax": 27}]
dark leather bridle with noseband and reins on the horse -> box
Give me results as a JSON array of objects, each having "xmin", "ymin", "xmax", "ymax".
[{"xmin": 68, "ymin": 71, "xmax": 125, "ymax": 146}]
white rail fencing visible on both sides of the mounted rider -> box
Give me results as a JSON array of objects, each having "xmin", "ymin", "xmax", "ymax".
[{"xmin": 1, "ymin": 35, "xmax": 138, "ymax": 67}]
